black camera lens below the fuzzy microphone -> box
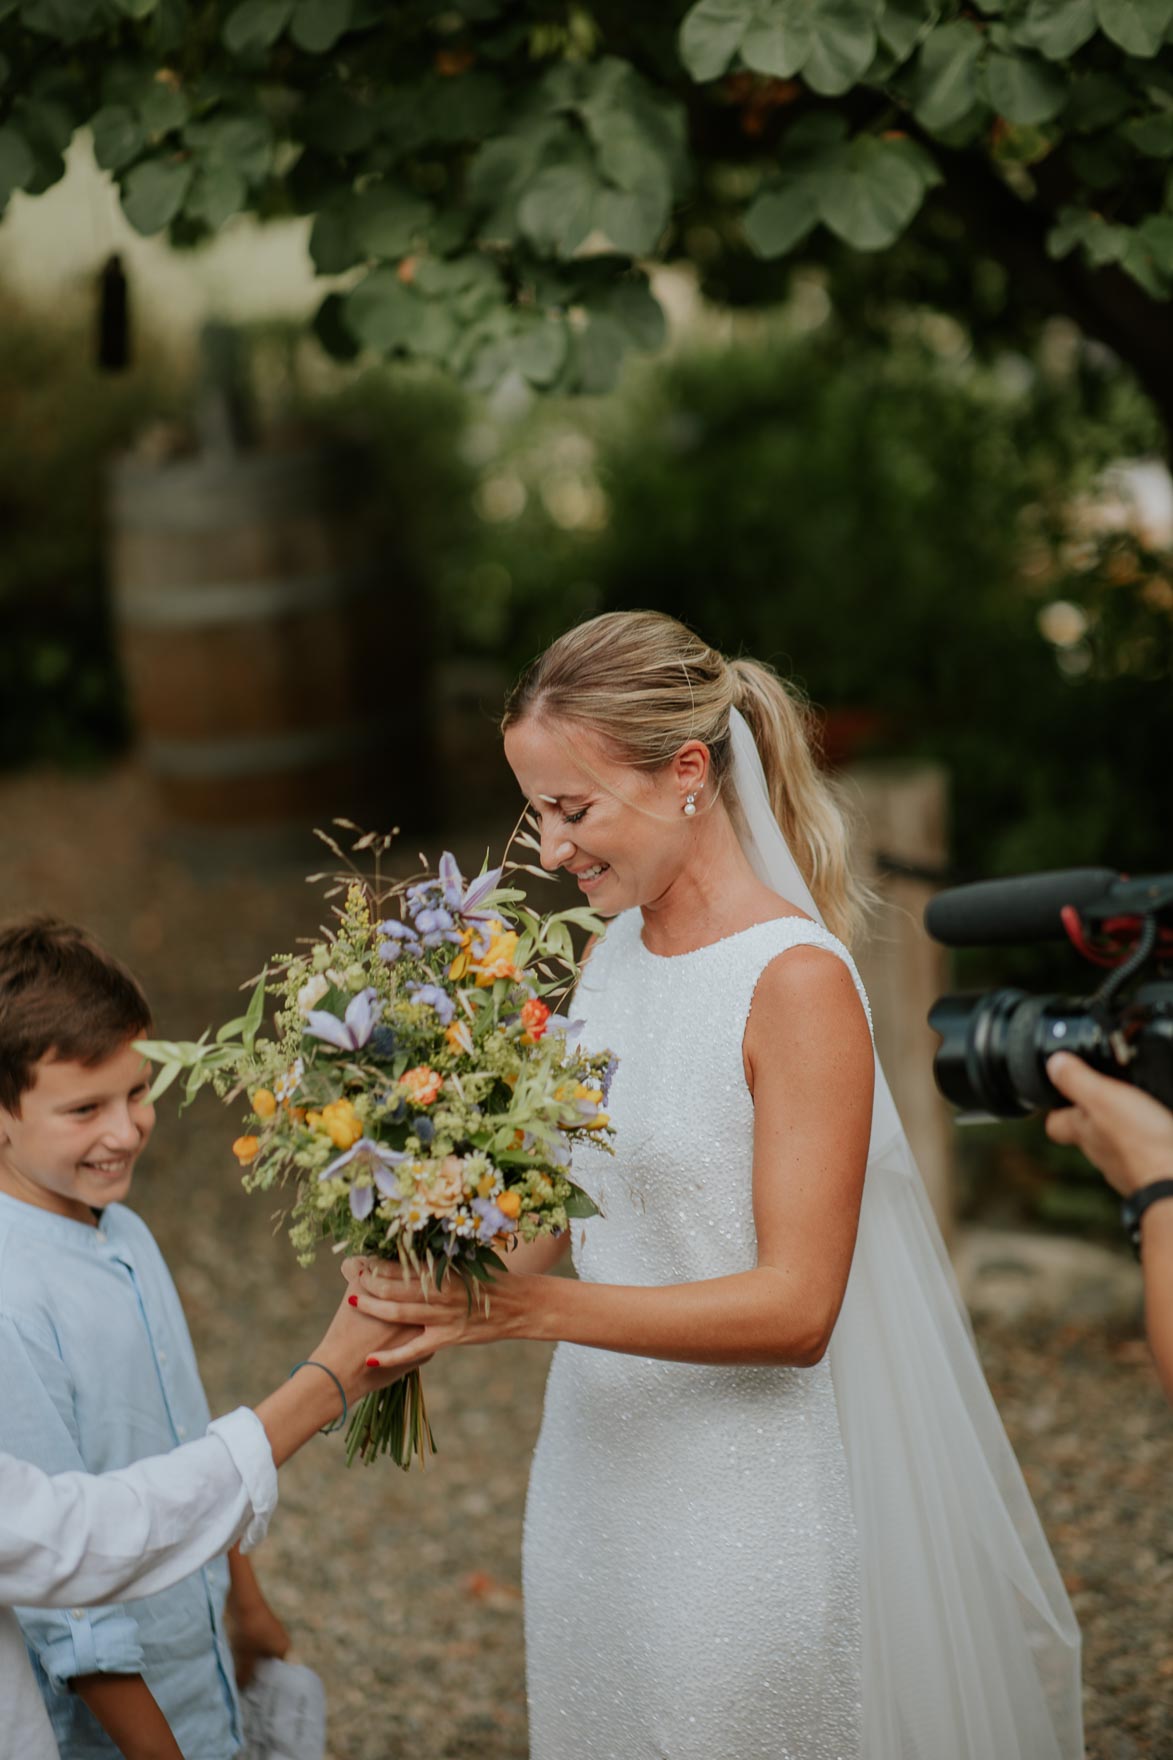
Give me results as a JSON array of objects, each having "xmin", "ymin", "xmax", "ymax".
[{"xmin": 928, "ymin": 987, "xmax": 1118, "ymax": 1118}]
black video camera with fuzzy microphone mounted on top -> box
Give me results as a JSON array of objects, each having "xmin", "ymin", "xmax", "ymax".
[{"xmin": 925, "ymin": 868, "xmax": 1173, "ymax": 1118}]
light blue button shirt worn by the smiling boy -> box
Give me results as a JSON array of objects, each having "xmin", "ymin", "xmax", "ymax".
[{"xmin": 0, "ymin": 1193, "xmax": 241, "ymax": 1760}]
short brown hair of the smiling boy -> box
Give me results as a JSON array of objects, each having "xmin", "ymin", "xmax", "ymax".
[{"xmin": 0, "ymin": 917, "xmax": 151, "ymax": 1112}]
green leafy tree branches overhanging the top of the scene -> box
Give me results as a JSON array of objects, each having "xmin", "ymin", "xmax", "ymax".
[{"xmin": 0, "ymin": 0, "xmax": 1173, "ymax": 403}]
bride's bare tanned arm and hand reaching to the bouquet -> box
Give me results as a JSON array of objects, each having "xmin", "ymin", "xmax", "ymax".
[{"xmin": 352, "ymin": 947, "xmax": 874, "ymax": 1366}]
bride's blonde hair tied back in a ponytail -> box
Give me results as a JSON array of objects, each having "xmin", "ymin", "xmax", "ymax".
[{"xmin": 502, "ymin": 611, "xmax": 872, "ymax": 943}]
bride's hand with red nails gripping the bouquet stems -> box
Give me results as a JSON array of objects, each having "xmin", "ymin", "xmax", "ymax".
[{"xmin": 332, "ymin": 1258, "xmax": 534, "ymax": 1369}]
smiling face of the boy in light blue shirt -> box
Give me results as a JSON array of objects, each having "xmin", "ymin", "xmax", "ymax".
[{"xmin": 0, "ymin": 1040, "xmax": 155, "ymax": 1223}]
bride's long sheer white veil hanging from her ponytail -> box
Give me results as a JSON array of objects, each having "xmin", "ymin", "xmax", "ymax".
[{"xmin": 729, "ymin": 709, "xmax": 1083, "ymax": 1760}]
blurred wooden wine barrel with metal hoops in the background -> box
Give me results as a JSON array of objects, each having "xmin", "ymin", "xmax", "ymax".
[{"xmin": 109, "ymin": 440, "xmax": 428, "ymax": 829}]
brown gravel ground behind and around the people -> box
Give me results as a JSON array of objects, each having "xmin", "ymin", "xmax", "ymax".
[{"xmin": 0, "ymin": 769, "xmax": 1173, "ymax": 1760}]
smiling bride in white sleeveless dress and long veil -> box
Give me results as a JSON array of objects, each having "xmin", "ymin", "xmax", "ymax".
[{"xmin": 345, "ymin": 612, "xmax": 1083, "ymax": 1760}]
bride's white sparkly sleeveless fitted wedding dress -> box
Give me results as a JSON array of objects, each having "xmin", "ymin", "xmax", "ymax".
[{"xmin": 523, "ymin": 910, "xmax": 866, "ymax": 1760}]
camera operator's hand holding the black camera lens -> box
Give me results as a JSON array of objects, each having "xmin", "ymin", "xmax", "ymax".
[{"xmin": 1046, "ymin": 1051, "xmax": 1173, "ymax": 1202}]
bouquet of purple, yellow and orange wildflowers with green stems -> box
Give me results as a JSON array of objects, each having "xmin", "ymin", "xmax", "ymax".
[{"xmin": 139, "ymin": 820, "xmax": 613, "ymax": 1466}]
